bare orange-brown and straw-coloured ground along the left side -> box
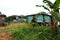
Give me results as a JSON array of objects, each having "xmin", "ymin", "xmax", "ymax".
[{"xmin": 0, "ymin": 23, "xmax": 27, "ymax": 40}]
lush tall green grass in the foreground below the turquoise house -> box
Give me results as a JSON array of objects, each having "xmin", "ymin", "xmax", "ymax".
[{"xmin": 11, "ymin": 26, "xmax": 60, "ymax": 40}]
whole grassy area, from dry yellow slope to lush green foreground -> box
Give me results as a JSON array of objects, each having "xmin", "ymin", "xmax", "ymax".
[{"xmin": 0, "ymin": 23, "xmax": 60, "ymax": 40}]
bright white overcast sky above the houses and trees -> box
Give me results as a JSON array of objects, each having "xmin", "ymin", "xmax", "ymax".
[{"xmin": 0, "ymin": 0, "xmax": 55, "ymax": 16}]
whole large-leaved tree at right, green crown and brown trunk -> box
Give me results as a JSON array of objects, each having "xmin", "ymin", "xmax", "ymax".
[{"xmin": 36, "ymin": 0, "xmax": 60, "ymax": 32}]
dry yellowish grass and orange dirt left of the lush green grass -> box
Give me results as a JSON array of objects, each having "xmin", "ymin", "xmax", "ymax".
[{"xmin": 0, "ymin": 22, "xmax": 27, "ymax": 40}]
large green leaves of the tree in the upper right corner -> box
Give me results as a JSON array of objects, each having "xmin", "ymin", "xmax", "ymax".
[{"xmin": 36, "ymin": 0, "xmax": 60, "ymax": 21}]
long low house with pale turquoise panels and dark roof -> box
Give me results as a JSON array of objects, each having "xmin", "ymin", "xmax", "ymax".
[{"xmin": 28, "ymin": 12, "xmax": 52, "ymax": 26}]
